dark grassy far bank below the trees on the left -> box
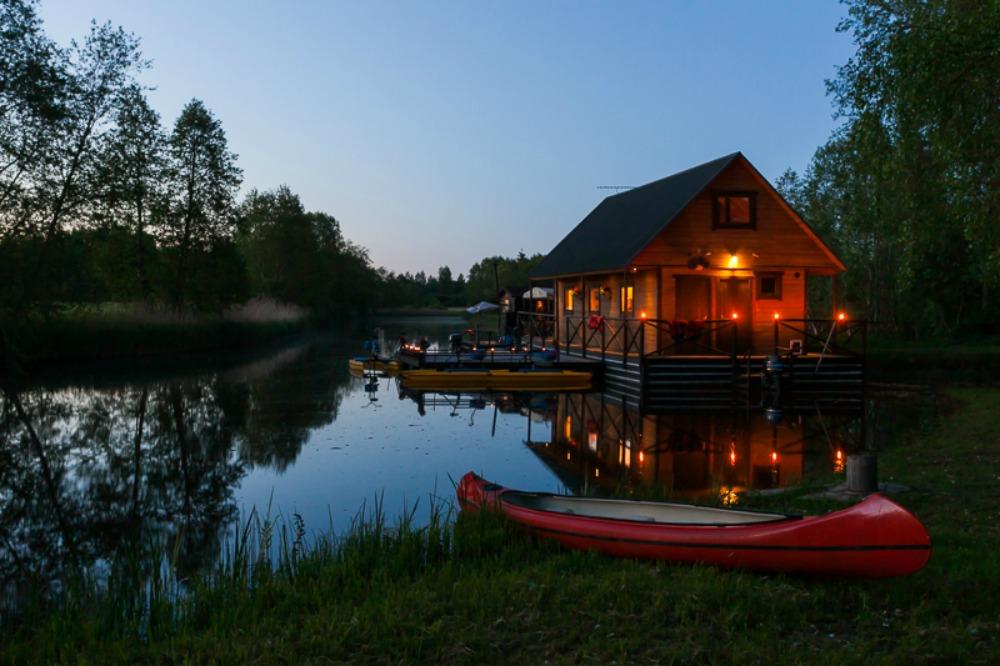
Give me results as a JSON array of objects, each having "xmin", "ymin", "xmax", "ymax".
[{"xmin": 22, "ymin": 301, "xmax": 308, "ymax": 364}]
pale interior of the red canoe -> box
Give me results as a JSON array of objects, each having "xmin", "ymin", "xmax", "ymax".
[{"xmin": 503, "ymin": 491, "xmax": 799, "ymax": 525}]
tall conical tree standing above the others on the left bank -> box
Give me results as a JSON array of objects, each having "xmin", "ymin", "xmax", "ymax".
[{"xmin": 163, "ymin": 99, "xmax": 242, "ymax": 305}]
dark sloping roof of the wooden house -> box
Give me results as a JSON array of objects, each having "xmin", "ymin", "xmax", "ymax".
[{"xmin": 529, "ymin": 152, "xmax": 740, "ymax": 278}]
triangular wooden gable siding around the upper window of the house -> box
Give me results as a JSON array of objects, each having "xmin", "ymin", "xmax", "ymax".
[{"xmin": 633, "ymin": 160, "xmax": 839, "ymax": 274}]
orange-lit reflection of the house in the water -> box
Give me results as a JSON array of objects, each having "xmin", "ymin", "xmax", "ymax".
[{"xmin": 527, "ymin": 394, "xmax": 863, "ymax": 504}]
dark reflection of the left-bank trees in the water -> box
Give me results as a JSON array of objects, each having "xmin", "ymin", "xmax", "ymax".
[{"xmin": 0, "ymin": 340, "xmax": 358, "ymax": 599}]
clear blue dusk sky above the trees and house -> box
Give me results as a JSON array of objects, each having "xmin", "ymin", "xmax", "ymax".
[{"xmin": 39, "ymin": 0, "xmax": 853, "ymax": 275}]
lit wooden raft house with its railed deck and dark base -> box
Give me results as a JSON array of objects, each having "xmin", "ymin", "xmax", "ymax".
[{"xmin": 401, "ymin": 152, "xmax": 867, "ymax": 410}]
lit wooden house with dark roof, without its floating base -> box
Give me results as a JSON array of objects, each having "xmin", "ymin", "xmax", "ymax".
[{"xmin": 530, "ymin": 152, "xmax": 845, "ymax": 356}]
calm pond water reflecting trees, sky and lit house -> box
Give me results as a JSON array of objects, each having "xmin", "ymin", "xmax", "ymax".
[{"xmin": 0, "ymin": 320, "xmax": 936, "ymax": 586}]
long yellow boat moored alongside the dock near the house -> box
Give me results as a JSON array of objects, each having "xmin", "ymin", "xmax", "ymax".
[{"xmin": 403, "ymin": 368, "xmax": 592, "ymax": 391}]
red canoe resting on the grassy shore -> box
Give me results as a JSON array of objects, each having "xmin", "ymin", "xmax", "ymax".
[{"xmin": 457, "ymin": 472, "xmax": 931, "ymax": 577}]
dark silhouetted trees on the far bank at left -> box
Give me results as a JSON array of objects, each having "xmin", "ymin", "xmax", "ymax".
[{"xmin": 0, "ymin": 0, "xmax": 388, "ymax": 319}]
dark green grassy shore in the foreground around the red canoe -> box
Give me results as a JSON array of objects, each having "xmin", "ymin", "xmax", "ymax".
[{"xmin": 0, "ymin": 388, "xmax": 1000, "ymax": 664}]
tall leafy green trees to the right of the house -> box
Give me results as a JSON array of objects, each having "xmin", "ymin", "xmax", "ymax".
[{"xmin": 777, "ymin": 0, "xmax": 1000, "ymax": 338}]
